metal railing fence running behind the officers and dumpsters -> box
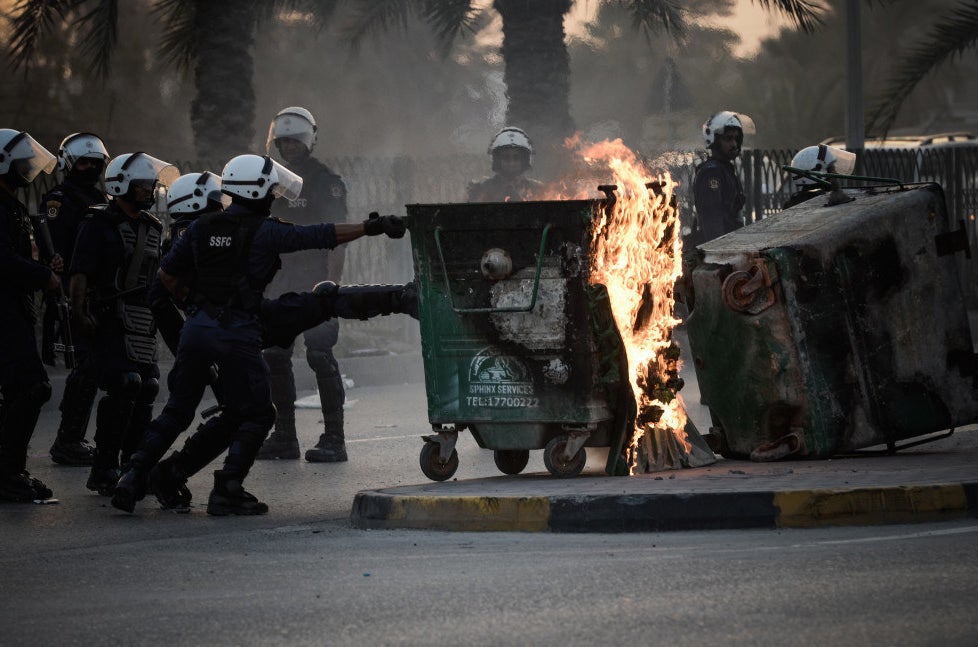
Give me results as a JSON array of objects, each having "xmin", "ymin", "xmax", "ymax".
[{"xmin": 23, "ymin": 146, "xmax": 978, "ymax": 352}]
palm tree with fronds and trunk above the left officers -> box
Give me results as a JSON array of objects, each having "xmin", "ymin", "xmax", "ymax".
[{"xmin": 10, "ymin": 0, "xmax": 337, "ymax": 160}]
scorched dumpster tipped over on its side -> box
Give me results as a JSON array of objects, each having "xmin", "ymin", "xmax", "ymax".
[{"xmin": 687, "ymin": 184, "xmax": 978, "ymax": 461}]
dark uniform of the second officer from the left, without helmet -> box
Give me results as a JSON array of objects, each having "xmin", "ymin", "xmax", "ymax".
[{"xmin": 39, "ymin": 174, "xmax": 105, "ymax": 465}]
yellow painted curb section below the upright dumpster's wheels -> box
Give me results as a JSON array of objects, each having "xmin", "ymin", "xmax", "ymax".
[{"xmin": 387, "ymin": 496, "xmax": 550, "ymax": 532}]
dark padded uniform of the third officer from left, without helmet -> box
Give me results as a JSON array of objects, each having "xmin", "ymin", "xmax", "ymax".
[{"xmin": 69, "ymin": 202, "xmax": 163, "ymax": 495}]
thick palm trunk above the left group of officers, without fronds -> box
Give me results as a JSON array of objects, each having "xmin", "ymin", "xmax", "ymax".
[{"xmin": 190, "ymin": 0, "xmax": 255, "ymax": 162}]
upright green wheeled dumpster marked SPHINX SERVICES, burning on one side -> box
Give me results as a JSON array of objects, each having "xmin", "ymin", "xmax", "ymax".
[{"xmin": 407, "ymin": 171, "xmax": 713, "ymax": 480}]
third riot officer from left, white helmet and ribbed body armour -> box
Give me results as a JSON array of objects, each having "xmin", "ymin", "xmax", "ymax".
[{"xmin": 69, "ymin": 152, "xmax": 179, "ymax": 496}]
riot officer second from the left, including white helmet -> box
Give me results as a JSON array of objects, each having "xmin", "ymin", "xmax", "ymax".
[{"xmin": 39, "ymin": 133, "xmax": 109, "ymax": 466}]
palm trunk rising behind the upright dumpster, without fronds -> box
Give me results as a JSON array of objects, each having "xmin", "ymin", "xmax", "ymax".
[{"xmin": 493, "ymin": 0, "xmax": 574, "ymax": 158}]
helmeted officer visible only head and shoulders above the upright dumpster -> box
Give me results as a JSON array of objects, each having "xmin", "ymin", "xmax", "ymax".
[{"xmin": 466, "ymin": 126, "xmax": 543, "ymax": 202}]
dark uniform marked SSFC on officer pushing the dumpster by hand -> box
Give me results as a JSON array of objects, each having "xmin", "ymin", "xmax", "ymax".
[{"xmin": 143, "ymin": 205, "xmax": 336, "ymax": 515}]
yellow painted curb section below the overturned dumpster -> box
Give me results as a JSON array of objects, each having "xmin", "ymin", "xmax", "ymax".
[{"xmin": 774, "ymin": 484, "xmax": 968, "ymax": 528}]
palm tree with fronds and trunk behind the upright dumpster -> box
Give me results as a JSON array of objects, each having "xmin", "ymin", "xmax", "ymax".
[{"xmin": 348, "ymin": 0, "xmax": 824, "ymax": 153}]
